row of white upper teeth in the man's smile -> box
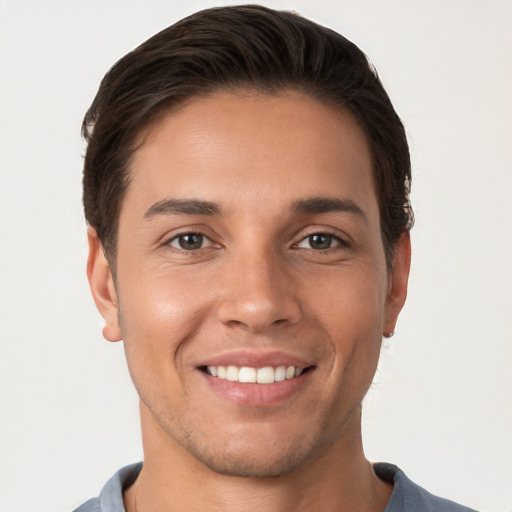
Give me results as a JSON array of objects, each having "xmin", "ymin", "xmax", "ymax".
[{"xmin": 206, "ymin": 365, "xmax": 304, "ymax": 384}]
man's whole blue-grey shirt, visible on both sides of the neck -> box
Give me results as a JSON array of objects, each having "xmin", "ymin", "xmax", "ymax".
[{"xmin": 74, "ymin": 462, "xmax": 476, "ymax": 512}]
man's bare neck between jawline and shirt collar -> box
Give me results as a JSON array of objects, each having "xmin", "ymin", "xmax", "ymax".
[{"xmin": 124, "ymin": 407, "xmax": 392, "ymax": 512}]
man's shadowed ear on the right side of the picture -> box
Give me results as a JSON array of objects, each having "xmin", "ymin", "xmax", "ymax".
[{"xmin": 383, "ymin": 230, "xmax": 411, "ymax": 337}]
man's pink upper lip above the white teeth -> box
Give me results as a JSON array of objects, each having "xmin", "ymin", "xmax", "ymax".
[{"xmin": 197, "ymin": 350, "xmax": 313, "ymax": 368}]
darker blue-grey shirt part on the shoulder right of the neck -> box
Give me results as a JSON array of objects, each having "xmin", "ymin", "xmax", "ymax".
[{"xmin": 373, "ymin": 463, "xmax": 476, "ymax": 512}]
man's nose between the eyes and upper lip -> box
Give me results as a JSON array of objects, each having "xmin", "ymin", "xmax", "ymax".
[{"xmin": 217, "ymin": 247, "xmax": 302, "ymax": 333}]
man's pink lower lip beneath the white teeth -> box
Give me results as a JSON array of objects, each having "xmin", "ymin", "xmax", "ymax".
[{"xmin": 200, "ymin": 370, "xmax": 313, "ymax": 407}]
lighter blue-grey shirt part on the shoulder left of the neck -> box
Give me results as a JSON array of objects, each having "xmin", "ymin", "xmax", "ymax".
[{"xmin": 73, "ymin": 462, "xmax": 142, "ymax": 512}]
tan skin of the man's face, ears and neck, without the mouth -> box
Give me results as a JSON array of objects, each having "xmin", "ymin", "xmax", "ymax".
[{"xmin": 88, "ymin": 91, "xmax": 410, "ymax": 512}]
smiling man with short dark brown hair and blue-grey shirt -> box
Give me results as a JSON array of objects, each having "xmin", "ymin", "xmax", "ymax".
[{"xmin": 78, "ymin": 6, "xmax": 476, "ymax": 512}]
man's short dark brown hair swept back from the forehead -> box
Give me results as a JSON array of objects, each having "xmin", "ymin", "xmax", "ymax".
[{"xmin": 82, "ymin": 5, "xmax": 413, "ymax": 265}]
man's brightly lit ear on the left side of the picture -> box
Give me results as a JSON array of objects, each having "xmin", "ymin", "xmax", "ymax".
[{"xmin": 87, "ymin": 226, "xmax": 122, "ymax": 341}]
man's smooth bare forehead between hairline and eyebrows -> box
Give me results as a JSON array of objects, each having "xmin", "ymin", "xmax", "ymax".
[{"xmin": 121, "ymin": 91, "xmax": 376, "ymax": 220}]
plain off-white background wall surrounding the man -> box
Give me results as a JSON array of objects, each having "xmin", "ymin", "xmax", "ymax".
[{"xmin": 0, "ymin": 0, "xmax": 512, "ymax": 512}]
